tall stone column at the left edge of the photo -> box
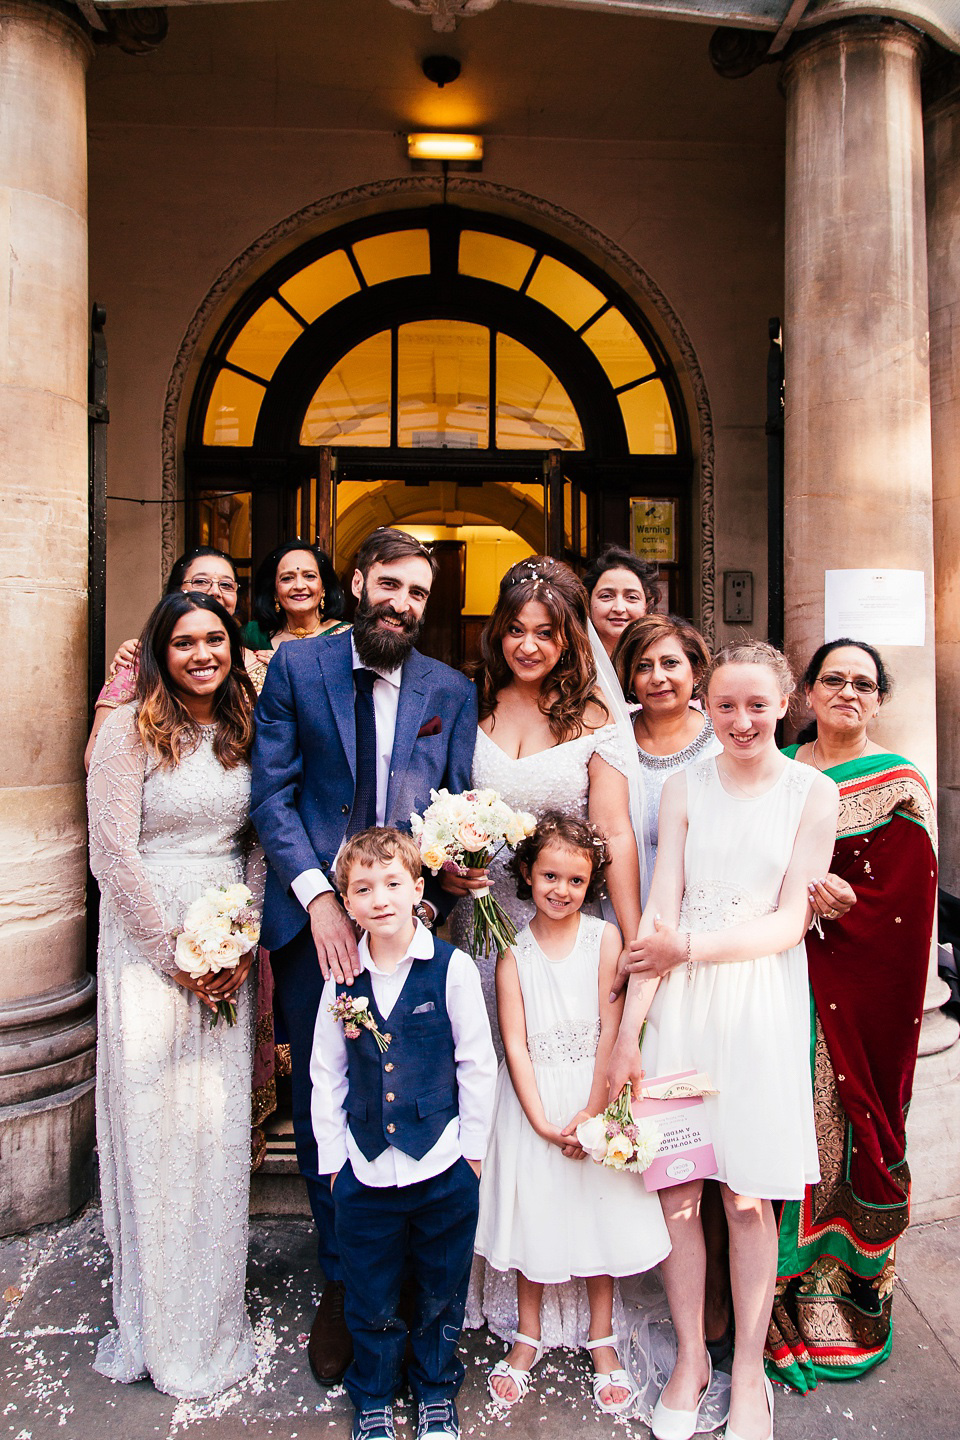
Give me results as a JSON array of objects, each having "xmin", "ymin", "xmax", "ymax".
[{"xmin": 0, "ymin": 0, "xmax": 95, "ymax": 1234}]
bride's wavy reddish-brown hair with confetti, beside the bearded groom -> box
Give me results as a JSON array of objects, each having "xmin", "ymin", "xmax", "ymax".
[{"xmin": 469, "ymin": 554, "xmax": 609, "ymax": 744}]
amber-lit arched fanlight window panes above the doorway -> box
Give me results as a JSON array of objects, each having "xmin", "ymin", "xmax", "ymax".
[{"xmin": 199, "ymin": 218, "xmax": 678, "ymax": 455}]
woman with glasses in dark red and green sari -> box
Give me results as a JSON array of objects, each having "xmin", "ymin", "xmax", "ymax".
[{"xmin": 766, "ymin": 639, "xmax": 937, "ymax": 1391}]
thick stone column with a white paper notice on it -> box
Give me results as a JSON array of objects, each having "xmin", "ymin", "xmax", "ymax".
[{"xmin": 784, "ymin": 20, "xmax": 960, "ymax": 1215}]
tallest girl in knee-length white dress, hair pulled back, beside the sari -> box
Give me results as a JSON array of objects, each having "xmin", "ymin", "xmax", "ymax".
[{"xmin": 609, "ymin": 641, "xmax": 839, "ymax": 1440}]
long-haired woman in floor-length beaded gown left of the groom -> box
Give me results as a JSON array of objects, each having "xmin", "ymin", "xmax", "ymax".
[{"xmin": 88, "ymin": 593, "xmax": 263, "ymax": 1398}]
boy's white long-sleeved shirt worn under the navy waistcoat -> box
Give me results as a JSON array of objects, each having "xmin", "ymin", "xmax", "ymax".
[{"xmin": 309, "ymin": 920, "xmax": 497, "ymax": 1188}]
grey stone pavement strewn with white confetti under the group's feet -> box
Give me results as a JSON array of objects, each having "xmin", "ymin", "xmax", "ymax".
[{"xmin": 0, "ymin": 1205, "xmax": 960, "ymax": 1440}]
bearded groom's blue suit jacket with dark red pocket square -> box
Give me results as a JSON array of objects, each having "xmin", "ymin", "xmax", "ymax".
[{"xmin": 250, "ymin": 631, "xmax": 476, "ymax": 950}]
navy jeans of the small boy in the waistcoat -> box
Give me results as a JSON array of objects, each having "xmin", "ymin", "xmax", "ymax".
[{"xmin": 334, "ymin": 1159, "xmax": 479, "ymax": 1410}]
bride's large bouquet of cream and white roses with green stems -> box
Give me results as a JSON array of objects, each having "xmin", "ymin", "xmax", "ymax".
[{"xmin": 410, "ymin": 791, "xmax": 537, "ymax": 960}]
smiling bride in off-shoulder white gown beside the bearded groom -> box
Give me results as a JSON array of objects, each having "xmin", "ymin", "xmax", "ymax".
[{"xmin": 443, "ymin": 556, "xmax": 650, "ymax": 1346}]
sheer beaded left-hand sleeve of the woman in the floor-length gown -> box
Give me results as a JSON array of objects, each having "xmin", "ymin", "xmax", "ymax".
[{"xmin": 86, "ymin": 706, "xmax": 178, "ymax": 975}]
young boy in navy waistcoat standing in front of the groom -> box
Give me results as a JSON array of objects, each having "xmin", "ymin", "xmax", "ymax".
[{"xmin": 309, "ymin": 828, "xmax": 497, "ymax": 1440}]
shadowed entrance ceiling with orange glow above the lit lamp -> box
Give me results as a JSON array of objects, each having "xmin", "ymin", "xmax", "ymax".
[{"xmin": 89, "ymin": 0, "xmax": 783, "ymax": 146}]
